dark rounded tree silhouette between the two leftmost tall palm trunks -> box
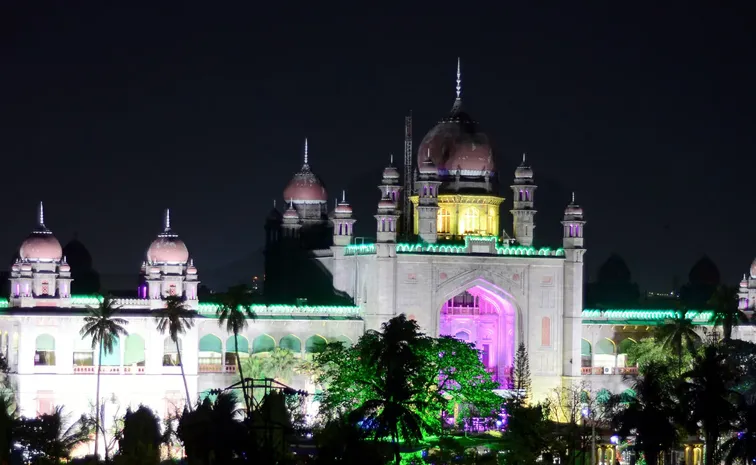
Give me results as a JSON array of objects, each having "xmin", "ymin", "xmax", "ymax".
[{"xmin": 116, "ymin": 405, "xmax": 163, "ymax": 465}]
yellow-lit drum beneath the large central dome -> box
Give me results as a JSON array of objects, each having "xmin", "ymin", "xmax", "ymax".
[{"xmin": 411, "ymin": 194, "xmax": 504, "ymax": 239}]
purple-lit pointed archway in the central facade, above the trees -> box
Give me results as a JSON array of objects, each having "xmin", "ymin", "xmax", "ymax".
[{"xmin": 439, "ymin": 282, "xmax": 517, "ymax": 384}]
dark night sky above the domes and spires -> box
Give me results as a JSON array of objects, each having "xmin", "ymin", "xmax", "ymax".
[{"xmin": 0, "ymin": 1, "xmax": 756, "ymax": 290}]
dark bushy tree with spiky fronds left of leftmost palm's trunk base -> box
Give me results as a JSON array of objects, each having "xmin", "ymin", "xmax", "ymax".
[{"xmin": 17, "ymin": 407, "xmax": 90, "ymax": 464}]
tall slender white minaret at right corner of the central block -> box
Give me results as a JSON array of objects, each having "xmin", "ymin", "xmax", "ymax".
[{"xmin": 562, "ymin": 192, "xmax": 585, "ymax": 381}]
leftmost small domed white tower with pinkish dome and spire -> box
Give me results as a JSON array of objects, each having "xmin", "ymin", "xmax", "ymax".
[{"xmin": 10, "ymin": 202, "xmax": 72, "ymax": 307}]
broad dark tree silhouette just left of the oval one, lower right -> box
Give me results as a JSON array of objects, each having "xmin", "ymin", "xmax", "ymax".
[{"xmin": 609, "ymin": 362, "xmax": 680, "ymax": 465}]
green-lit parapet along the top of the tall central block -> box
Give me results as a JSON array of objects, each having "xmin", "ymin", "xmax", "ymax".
[{"xmin": 344, "ymin": 236, "xmax": 564, "ymax": 257}]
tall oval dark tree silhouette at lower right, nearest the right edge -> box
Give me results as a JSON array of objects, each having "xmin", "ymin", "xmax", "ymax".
[{"xmin": 680, "ymin": 345, "xmax": 739, "ymax": 465}]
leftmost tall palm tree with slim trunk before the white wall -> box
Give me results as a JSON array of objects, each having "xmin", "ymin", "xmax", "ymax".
[{"xmin": 79, "ymin": 296, "xmax": 128, "ymax": 457}]
